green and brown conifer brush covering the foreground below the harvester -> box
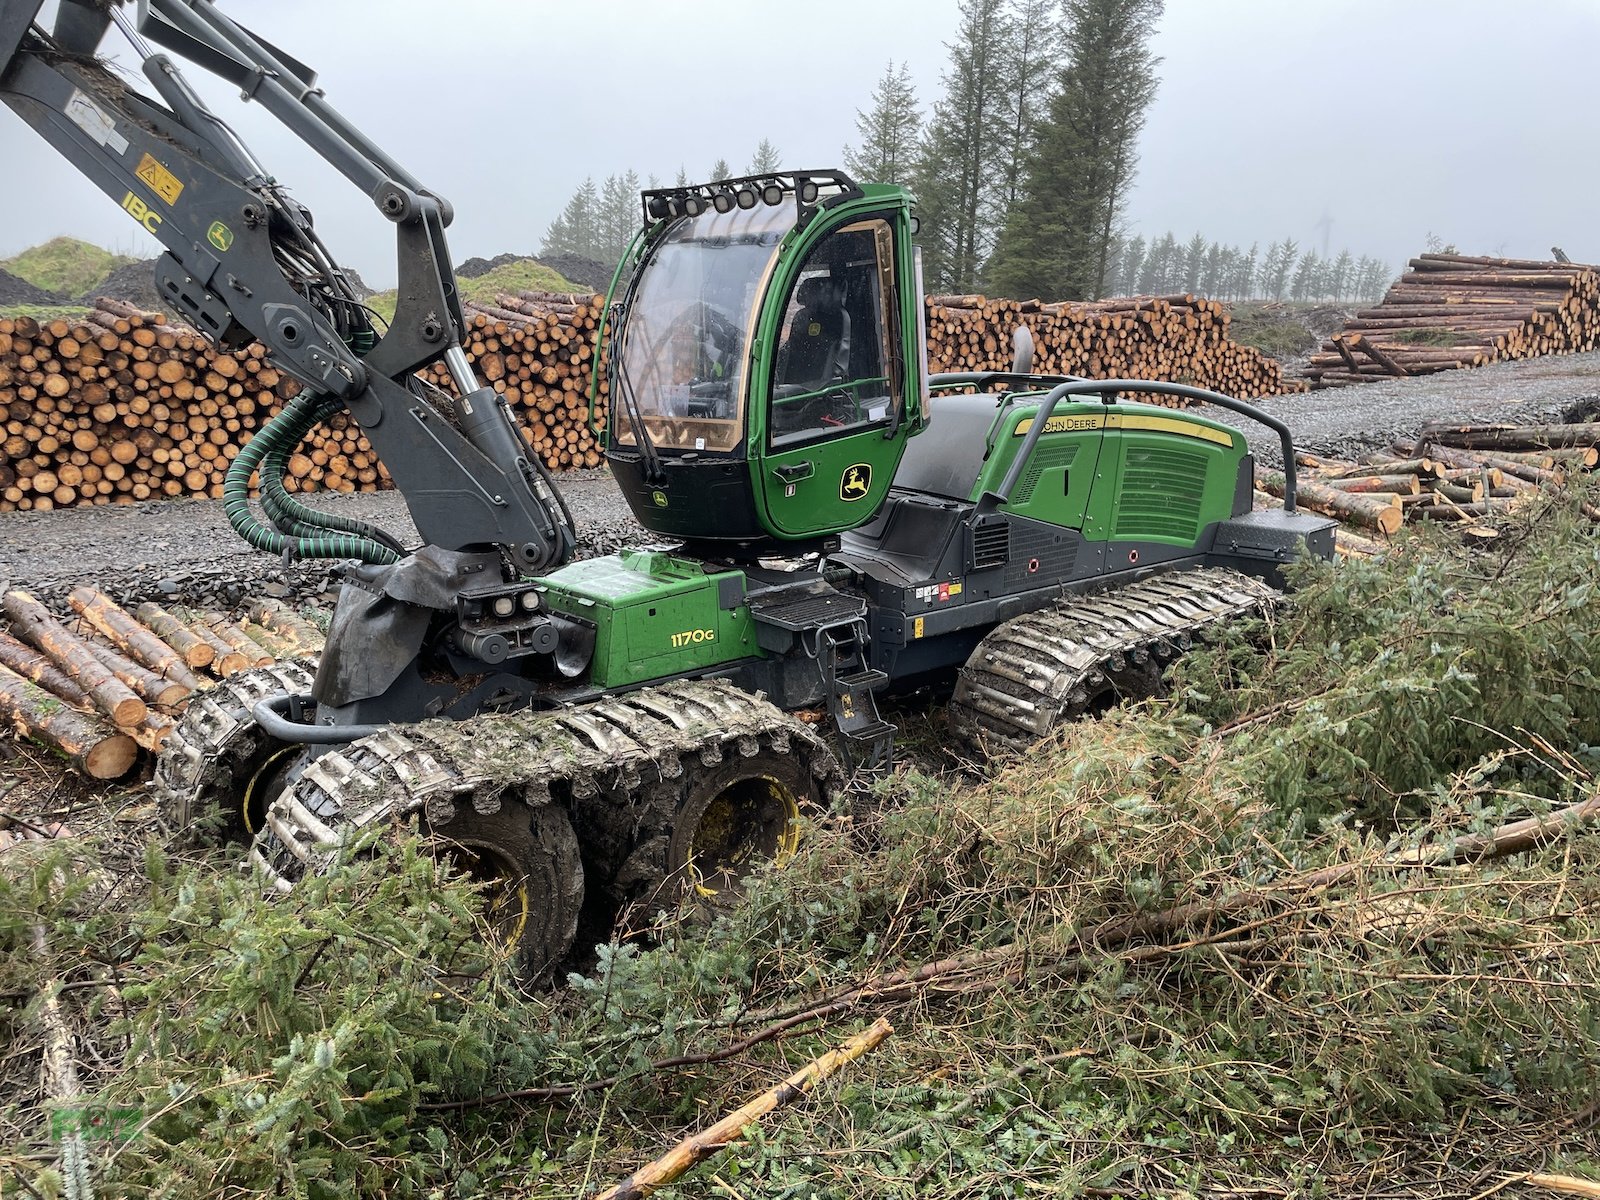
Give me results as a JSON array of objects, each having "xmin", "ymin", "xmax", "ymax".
[{"xmin": 0, "ymin": 496, "xmax": 1600, "ymax": 1200}]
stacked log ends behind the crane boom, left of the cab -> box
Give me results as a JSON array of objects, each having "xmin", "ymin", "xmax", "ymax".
[{"xmin": 0, "ymin": 293, "xmax": 605, "ymax": 512}]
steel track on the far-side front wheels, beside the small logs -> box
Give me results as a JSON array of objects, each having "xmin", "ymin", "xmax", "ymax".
[{"xmin": 152, "ymin": 659, "xmax": 317, "ymax": 829}]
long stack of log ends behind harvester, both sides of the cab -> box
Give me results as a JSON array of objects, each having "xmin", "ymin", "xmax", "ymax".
[{"xmin": 0, "ymin": 291, "xmax": 1299, "ymax": 512}]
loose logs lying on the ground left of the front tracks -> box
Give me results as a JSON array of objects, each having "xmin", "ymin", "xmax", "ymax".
[{"xmin": 0, "ymin": 586, "xmax": 322, "ymax": 779}]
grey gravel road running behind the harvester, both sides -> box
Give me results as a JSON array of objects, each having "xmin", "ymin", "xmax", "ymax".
[{"xmin": 0, "ymin": 352, "xmax": 1600, "ymax": 606}]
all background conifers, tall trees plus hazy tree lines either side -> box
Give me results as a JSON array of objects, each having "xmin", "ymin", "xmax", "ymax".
[{"xmin": 539, "ymin": 0, "xmax": 1389, "ymax": 301}]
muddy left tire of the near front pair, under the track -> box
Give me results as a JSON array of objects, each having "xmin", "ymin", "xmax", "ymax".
[{"xmin": 427, "ymin": 795, "xmax": 584, "ymax": 982}]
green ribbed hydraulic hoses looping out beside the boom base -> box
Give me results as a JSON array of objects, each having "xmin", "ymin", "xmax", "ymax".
[{"xmin": 222, "ymin": 392, "xmax": 400, "ymax": 563}]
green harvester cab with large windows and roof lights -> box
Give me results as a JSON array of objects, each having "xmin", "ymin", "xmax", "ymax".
[{"xmin": 606, "ymin": 171, "xmax": 926, "ymax": 558}]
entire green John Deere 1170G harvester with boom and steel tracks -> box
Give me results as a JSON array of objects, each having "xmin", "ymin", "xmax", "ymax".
[{"xmin": 0, "ymin": 0, "xmax": 1333, "ymax": 973}]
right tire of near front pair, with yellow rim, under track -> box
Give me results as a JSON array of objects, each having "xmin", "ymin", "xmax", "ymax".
[{"xmin": 666, "ymin": 752, "xmax": 819, "ymax": 901}]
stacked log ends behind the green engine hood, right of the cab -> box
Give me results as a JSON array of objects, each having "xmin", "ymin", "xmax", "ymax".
[{"xmin": 928, "ymin": 296, "xmax": 1304, "ymax": 403}]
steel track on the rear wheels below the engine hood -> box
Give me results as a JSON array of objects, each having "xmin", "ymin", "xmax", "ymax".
[{"xmin": 950, "ymin": 568, "xmax": 1280, "ymax": 750}]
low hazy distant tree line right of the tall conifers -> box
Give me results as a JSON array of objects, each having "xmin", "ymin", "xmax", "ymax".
[{"xmin": 1106, "ymin": 234, "xmax": 1394, "ymax": 304}]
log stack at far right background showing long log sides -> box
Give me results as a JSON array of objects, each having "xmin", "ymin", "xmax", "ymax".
[{"xmin": 1306, "ymin": 254, "xmax": 1600, "ymax": 389}]
